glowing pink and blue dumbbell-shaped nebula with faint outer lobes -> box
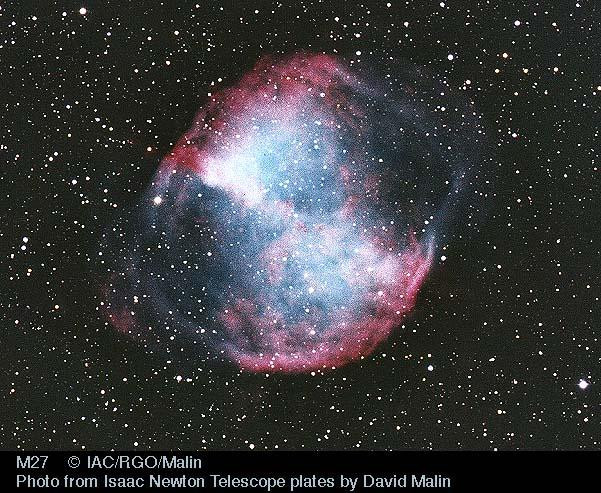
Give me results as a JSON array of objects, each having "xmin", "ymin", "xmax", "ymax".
[{"xmin": 102, "ymin": 54, "xmax": 479, "ymax": 372}]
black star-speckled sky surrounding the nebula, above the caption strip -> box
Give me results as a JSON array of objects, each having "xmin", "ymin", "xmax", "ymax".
[{"xmin": 0, "ymin": 0, "xmax": 601, "ymax": 450}]
